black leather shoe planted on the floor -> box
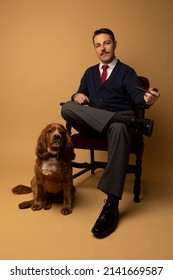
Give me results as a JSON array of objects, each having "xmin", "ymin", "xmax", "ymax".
[{"xmin": 91, "ymin": 203, "xmax": 119, "ymax": 238}]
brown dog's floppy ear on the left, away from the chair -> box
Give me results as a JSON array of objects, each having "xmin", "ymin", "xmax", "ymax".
[{"xmin": 36, "ymin": 126, "xmax": 49, "ymax": 159}]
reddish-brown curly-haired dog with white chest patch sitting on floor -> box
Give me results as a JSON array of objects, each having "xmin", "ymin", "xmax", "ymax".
[{"xmin": 12, "ymin": 123, "xmax": 75, "ymax": 215}]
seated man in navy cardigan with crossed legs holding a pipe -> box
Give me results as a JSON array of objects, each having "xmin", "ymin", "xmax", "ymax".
[{"xmin": 62, "ymin": 28, "xmax": 159, "ymax": 238}]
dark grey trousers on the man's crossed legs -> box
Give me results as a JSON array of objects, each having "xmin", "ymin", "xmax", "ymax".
[{"xmin": 61, "ymin": 101, "xmax": 132, "ymax": 199}]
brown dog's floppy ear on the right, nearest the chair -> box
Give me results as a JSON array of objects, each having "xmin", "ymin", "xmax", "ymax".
[{"xmin": 59, "ymin": 124, "xmax": 75, "ymax": 161}]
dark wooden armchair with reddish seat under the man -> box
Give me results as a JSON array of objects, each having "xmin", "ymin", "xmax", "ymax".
[{"xmin": 60, "ymin": 76, "xmax": 150, "ymax": 203}]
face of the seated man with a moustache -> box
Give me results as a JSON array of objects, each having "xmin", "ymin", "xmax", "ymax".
[{"xmin": 93, "ymin": 33, "xmax": 116, "ymax": 64}]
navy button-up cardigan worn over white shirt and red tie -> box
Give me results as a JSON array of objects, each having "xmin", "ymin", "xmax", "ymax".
[{"xmin": 72, "ymin": 60, "xmax": 147, "ymax": 112}]
